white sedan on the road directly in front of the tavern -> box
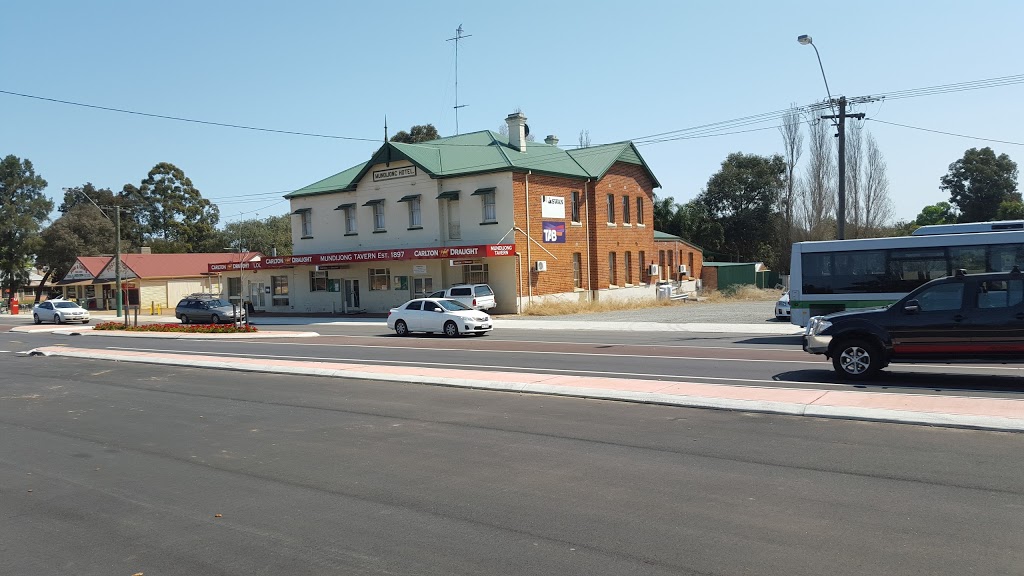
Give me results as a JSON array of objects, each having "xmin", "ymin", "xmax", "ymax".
[{"xmin": 387, "ymin": 298, "xmax": 494, "ymax": 337}]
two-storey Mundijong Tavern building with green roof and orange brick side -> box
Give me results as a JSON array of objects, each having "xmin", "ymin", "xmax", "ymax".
[{"xmin": 210, "ymin": 113, "xmax": 670, "ymax": 313}]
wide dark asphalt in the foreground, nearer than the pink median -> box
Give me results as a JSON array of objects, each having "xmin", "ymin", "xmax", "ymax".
[{"xmin": 0, "ymin": 352, "xmax": 1024, "ymax": 576}]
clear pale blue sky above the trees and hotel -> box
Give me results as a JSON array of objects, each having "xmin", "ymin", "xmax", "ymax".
[{"xmin": 0, "ymin": 0, "xmax": 1024, "ymax": 222}]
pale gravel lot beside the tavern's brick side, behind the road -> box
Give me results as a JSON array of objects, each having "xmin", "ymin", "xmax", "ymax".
[{"xmin": 502, "ymin": 300, "xmax": 787, "ymax": 324}]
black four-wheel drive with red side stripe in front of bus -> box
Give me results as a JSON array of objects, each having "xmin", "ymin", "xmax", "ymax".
[{"xmin": 804, "ymin": 266, "xmax": 1024, "ymax": 379}]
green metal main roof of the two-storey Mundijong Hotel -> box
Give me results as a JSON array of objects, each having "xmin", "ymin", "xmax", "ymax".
[{"xmin": 285, "ymin": 130, "xmax": 662, "ymax": 198}]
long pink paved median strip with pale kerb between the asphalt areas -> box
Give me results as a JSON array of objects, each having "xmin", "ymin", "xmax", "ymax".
[{"xmin": 29, "ymin": 346, "xmax": 1024, "ymax": 431}]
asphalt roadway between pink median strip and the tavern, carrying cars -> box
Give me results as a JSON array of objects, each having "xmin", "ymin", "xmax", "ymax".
[{"xmin": 8, "ymin": 324, "xmax": 1024, "ymax": 398}]
